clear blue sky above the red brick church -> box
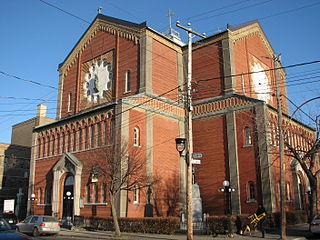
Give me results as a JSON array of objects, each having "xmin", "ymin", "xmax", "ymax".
[{"xmin": 0, "ymin": 0, "xmax": 320, "ymax": 143}]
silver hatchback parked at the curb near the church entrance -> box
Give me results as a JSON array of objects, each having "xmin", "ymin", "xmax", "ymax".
[{"xmin": 16, "ymin": 215, "xmax": 60, "ymax": 237}]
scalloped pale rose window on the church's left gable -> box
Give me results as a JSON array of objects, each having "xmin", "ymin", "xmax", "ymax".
[{"xmin": 84, "ymin": 58, "xmax": 113, "ymax": 102}]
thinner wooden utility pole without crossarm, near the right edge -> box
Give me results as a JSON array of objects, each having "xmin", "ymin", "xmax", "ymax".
[{"xmin": 272, "ymin": 55, "xmax": 287, "ymax": 240}]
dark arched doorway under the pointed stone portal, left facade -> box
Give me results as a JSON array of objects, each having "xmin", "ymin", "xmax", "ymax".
[{"xmin": 62, "ymin": 174, "xmax": 74, "ymax": 220}]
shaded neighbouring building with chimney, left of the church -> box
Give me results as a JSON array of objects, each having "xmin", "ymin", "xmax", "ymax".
[{"xmin": 0, "ymin": 104, "xmax": 54, "ymax": 219}]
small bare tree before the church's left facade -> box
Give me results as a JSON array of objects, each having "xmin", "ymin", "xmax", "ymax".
[{"xmin": 88, "ymin": 141, "xmax": 150, "ymax": 236}]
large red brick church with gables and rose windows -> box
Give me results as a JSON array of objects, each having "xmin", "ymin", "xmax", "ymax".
[{"xmin": 29, "ymin": 14, "xmax": 313, "ymax": 218}]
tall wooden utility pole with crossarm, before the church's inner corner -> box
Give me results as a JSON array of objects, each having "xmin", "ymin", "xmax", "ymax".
[{"xmin": 176, "ymin": 21, "xmax": 206, "ymax": 240}]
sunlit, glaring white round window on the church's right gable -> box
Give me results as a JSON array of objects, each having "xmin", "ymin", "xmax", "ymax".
[{"xmin": 251, "ymin": 62, "xmax": 271, "ymax": 103}]
